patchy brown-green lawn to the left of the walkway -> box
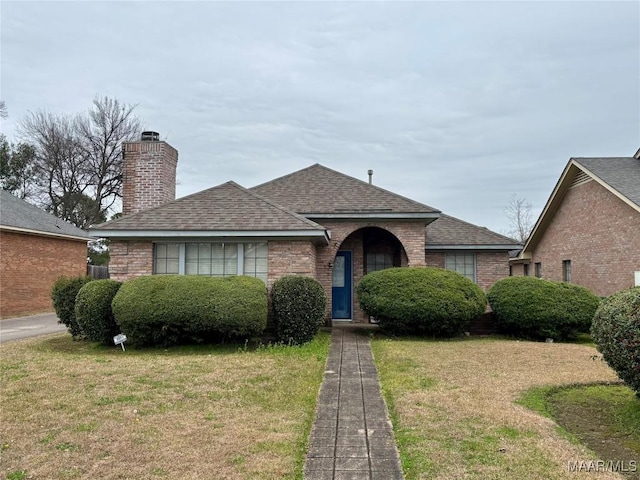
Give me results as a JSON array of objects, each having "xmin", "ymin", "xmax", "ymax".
[{"xmin": 0, "ymin": 333, "xmax": 329, "ymax": 480}]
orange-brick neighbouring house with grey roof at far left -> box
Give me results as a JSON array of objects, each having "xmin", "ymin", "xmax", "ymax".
[{"xmin": 0, "ymin": 190, "xmax": 90, "ymax": 318}]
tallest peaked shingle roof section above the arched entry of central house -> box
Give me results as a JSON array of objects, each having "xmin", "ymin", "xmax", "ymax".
[{"xmin": 251, "ymin": 164, "xmax": 440, "ymax": 219}]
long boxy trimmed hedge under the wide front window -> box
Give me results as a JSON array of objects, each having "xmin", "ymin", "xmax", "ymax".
[{"xmin": 112, "ymin": 275, "xmax": 267, "ymax": 346}]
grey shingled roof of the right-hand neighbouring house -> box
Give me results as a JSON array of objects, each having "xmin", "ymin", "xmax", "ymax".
[{"xmin": 572, "ymin": 157, "xmax": 640, "ymax": 208}]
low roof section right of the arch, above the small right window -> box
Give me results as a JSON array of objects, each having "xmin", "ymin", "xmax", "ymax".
[{"xmin": 426, "ymin": 214, "xmax": 521, "ymax": 251}]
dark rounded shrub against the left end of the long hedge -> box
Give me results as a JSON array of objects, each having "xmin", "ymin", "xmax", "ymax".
[{"xmin": 76, "ymin": 280, "xmax": 122, "ymax": 345}]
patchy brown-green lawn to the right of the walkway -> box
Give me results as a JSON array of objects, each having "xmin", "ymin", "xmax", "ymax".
[{"xmin": 372, "ymin": 337, "xmax": 632, "ymax": 480}]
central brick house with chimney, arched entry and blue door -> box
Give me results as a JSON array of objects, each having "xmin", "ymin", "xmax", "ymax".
[{"xmin": 90, "ymin": 132, "xmax": 518, "ymax": 322}]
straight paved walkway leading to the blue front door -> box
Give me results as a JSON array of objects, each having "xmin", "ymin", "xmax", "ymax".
[{"xmin": 304, "ymin": 327, "xmax": 403, "ymax": 480}]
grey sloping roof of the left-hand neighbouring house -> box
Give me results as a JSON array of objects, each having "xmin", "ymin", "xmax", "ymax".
[{"xmin": 0, "ymin": 190, "xmax": 91, "ymax": 242}]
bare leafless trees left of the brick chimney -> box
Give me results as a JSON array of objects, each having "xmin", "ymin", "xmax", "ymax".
[{"xmin": 19, "ymin": 96, "xmax": 141, "ymax": 228}]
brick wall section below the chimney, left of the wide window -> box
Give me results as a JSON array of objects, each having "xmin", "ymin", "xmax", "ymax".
[{"xmin": 109, "ymin": 240, "xmax": 153, "ymax": 282}]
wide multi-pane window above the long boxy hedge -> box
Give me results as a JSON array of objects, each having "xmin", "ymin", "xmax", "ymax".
[{"xmin": 153, "ymin": 242, "xmax": 269, "ymax": 283}]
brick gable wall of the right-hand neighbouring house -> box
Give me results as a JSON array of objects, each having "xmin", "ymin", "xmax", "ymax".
[{"xmin": 530, "ymin": 181, "xmax": 640, "ymax": 296}]
